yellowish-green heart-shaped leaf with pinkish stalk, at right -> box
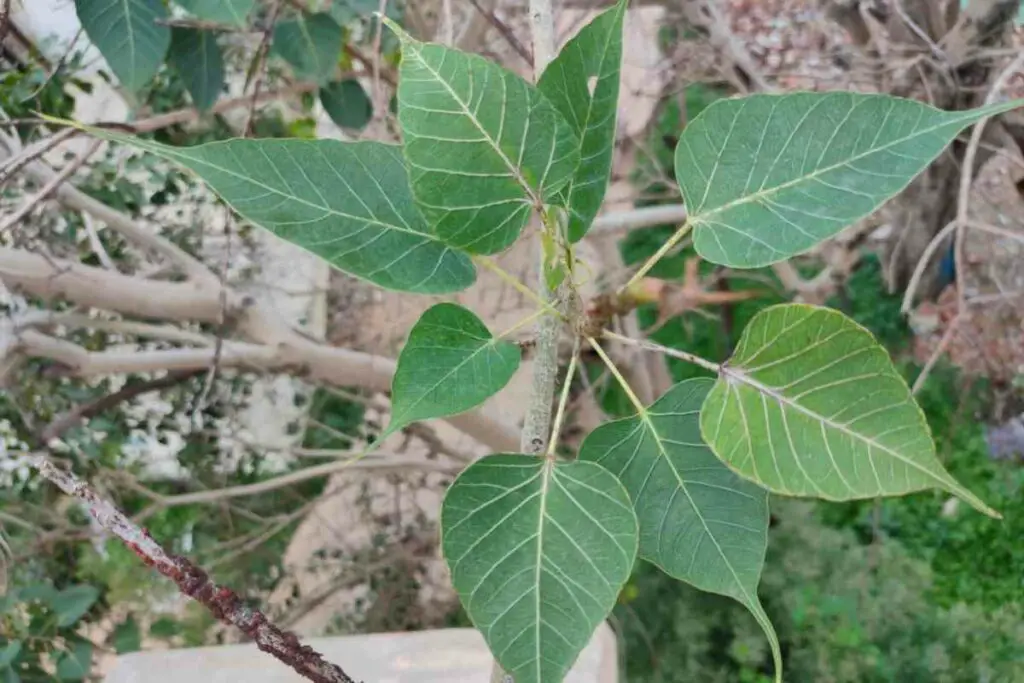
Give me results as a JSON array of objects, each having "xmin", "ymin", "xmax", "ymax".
[{"xmin": 700, "ymin": 304, "xmax": 998, "ymax": 517}]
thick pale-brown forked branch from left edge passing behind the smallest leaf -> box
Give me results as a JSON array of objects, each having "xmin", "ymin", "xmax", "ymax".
[{"xmin": 0, "ymin": 248, "xmax": 519, "ymax": 453}]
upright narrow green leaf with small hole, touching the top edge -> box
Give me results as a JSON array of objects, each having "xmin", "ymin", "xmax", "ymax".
[{"xmin": 537, "ymin": 0, "xmax": 629, "ymax": 242}]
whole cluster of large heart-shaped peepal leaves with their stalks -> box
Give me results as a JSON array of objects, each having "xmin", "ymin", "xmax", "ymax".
[{"xmin": 51, "ymin": 0, "xmax": 1020, "ymax": 683}]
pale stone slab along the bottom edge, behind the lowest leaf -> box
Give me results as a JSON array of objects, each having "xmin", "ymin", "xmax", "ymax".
[{"xmin": 105, "ymin": 624, "xmax": 618, "ymax": 683}]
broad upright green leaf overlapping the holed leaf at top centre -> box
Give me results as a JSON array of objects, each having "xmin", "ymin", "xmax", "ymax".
[{"xmin": 390, "ymin": 24, "xmax": 580, "ymax": 254}]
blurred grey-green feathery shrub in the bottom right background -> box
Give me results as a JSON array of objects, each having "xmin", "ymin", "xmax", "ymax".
[{"xmin": 615, "ymin": 498, "xmax": 1024, "ymax": 683}]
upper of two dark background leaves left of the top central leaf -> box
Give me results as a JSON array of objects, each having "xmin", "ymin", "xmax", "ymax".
[{"xmin": 273, "ymin": 12, "xmax": 344, "ymax": 84}]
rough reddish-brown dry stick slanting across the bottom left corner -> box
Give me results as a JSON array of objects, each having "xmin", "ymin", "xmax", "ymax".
[{"xmin": 33, "ymin": 456, "xmax": 355, "ymax": 683}]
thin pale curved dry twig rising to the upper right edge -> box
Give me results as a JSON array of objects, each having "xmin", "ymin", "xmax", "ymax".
[{"xmin": 903, "ymin": 52, "xmax": 1024, "ymax": 393}]
